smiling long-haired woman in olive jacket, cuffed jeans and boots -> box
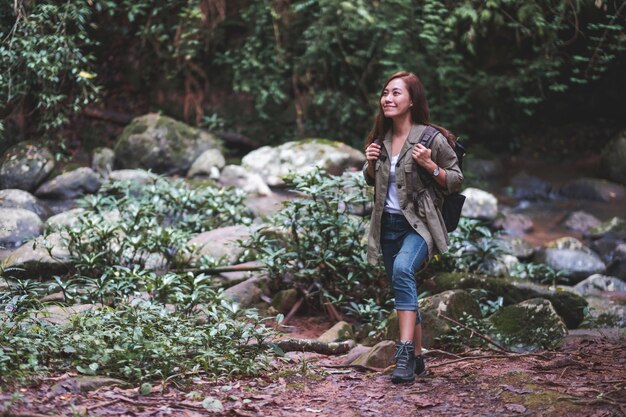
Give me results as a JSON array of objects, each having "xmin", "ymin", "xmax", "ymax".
[{"xmin": 363, "ymin": 72, "xmax": 463, "ymax": 383}]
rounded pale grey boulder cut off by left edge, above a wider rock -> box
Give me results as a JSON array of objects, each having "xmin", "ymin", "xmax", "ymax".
[{"xmin": 0, "ymin": 208, "xmax": 43, "ymax": 249}]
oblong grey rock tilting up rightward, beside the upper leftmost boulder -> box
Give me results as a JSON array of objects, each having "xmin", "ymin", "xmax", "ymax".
[{"xmin": 35, "ymin": 168, "xmax": 102, "ymax": 200}]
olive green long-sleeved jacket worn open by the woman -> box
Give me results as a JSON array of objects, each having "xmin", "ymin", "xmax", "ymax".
[{"xmin": 363, "ymin": 125, "xmax": 463, "ymax": 264}]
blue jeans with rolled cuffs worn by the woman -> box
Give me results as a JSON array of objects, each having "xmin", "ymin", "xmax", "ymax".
[{"xmin": 380, "ymin": 213, "xmax": 428, "ymax": 324}]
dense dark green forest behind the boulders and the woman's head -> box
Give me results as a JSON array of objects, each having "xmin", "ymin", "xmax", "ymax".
[{"xmin": 0, "ymin": 0, "xmax": 626, "ymax": 156}]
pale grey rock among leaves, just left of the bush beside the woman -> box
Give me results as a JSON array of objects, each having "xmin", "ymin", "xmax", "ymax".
[{"xmin": 187, "ymin": 225, "xmax": 250, "ymax": 265}]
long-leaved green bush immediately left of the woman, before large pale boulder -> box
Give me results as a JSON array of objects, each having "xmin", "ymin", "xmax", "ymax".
[{"xmin": 243, "ymin": 169, "xmax": 388, "ymax": 314}]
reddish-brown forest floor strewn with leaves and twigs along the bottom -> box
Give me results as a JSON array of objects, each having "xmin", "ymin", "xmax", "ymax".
[{"xmin": 0, "ymin": 317, "xmax": 626, "ymax": 417}]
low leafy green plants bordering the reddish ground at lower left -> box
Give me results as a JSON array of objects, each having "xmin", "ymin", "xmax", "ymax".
[{"xmin": 0, "ymin": 299, "xmax": 273, "ymax": 382}]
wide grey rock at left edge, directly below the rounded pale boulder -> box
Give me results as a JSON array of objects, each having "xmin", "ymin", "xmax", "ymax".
[{"xmin": 2, "ymin": 233, "xmax": 70, "ymax": 279}]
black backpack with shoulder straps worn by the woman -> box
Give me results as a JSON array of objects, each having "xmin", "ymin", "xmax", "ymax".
[{"xmin": 412, "ymin": 126, "xmax": 465, "ymax": 233}]
